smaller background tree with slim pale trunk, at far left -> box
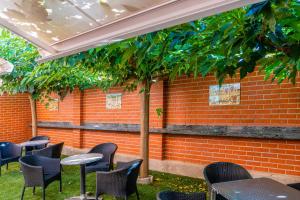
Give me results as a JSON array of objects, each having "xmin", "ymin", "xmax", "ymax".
[{"xmin": 0, "ymin": 29, "xmax": 99, "ymax": 136}]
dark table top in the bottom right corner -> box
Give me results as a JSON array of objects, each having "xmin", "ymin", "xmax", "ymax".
[{"xmin": 211, "ymin": 178, "xmax": 300, "ymax": 200}]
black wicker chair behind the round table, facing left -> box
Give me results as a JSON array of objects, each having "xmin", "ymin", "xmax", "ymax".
[{"xmin": 85, "ymin": 143, "xmax": 118, "ymax": 173}]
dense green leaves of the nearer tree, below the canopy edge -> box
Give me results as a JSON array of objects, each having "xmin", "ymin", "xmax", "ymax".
[{"xmin": 56, "ymin": 0, "xmax": 300, "ymax": 90}]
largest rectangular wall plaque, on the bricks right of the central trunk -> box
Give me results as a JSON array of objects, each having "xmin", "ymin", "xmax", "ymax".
[{"xmin": 209, "ymin": 83, "xmax": 241, "ymax": 106}]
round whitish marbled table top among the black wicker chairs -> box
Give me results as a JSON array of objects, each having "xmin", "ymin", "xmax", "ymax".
[{"xmin": 60, "ymin": 153, "xmax": 103, "ymax": 165}]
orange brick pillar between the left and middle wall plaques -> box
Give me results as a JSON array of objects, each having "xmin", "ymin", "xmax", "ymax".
[{"xmin": 72, "ymin": 89, "xmax": 83, "ymax": 148}]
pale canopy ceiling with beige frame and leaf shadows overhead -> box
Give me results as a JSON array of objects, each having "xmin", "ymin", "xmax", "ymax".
[{"xmin": 0, "ymin": 0, "xmax": 261, "ymax": 62}]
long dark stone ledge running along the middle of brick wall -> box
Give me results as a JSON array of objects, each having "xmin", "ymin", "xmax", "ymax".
[{"xmin": 38, "ymin": 122, "xmax": 300, "ymax": 140}]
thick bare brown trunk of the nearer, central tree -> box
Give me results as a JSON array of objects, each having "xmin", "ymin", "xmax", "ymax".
[{"xmin": 140, "ymin": 82, "xmax": 151, "ymax": 178}]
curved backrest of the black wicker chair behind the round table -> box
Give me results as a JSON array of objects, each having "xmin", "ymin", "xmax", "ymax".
[{"xmin": 89, "ymin": 143, "xmax": 118, "ymax": 169}]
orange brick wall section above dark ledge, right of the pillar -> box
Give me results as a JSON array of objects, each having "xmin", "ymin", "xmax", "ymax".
[{"xmin": 165, "ymin": 72, "xmax": 300, "ymax": 126}]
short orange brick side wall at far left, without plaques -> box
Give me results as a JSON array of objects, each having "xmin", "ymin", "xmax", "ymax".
[{"xmin": 0, "ymin": 94, "xmax": 31, "ymax": 143}]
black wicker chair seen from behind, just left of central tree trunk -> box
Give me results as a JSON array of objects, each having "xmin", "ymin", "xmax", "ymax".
[{"xmin": 96, "ymin": 159, "xmax": 143, "ymax": 200}]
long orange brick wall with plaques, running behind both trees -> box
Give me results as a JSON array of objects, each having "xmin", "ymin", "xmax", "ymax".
[{"xmin": 38, "ymin": 72, "xmax": 300, "ymax": 176}]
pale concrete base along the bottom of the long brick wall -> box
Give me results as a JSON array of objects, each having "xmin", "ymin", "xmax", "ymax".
[{"xmin": 63, "ymin": 147, "xmax": 300, "ymax": 184}]
